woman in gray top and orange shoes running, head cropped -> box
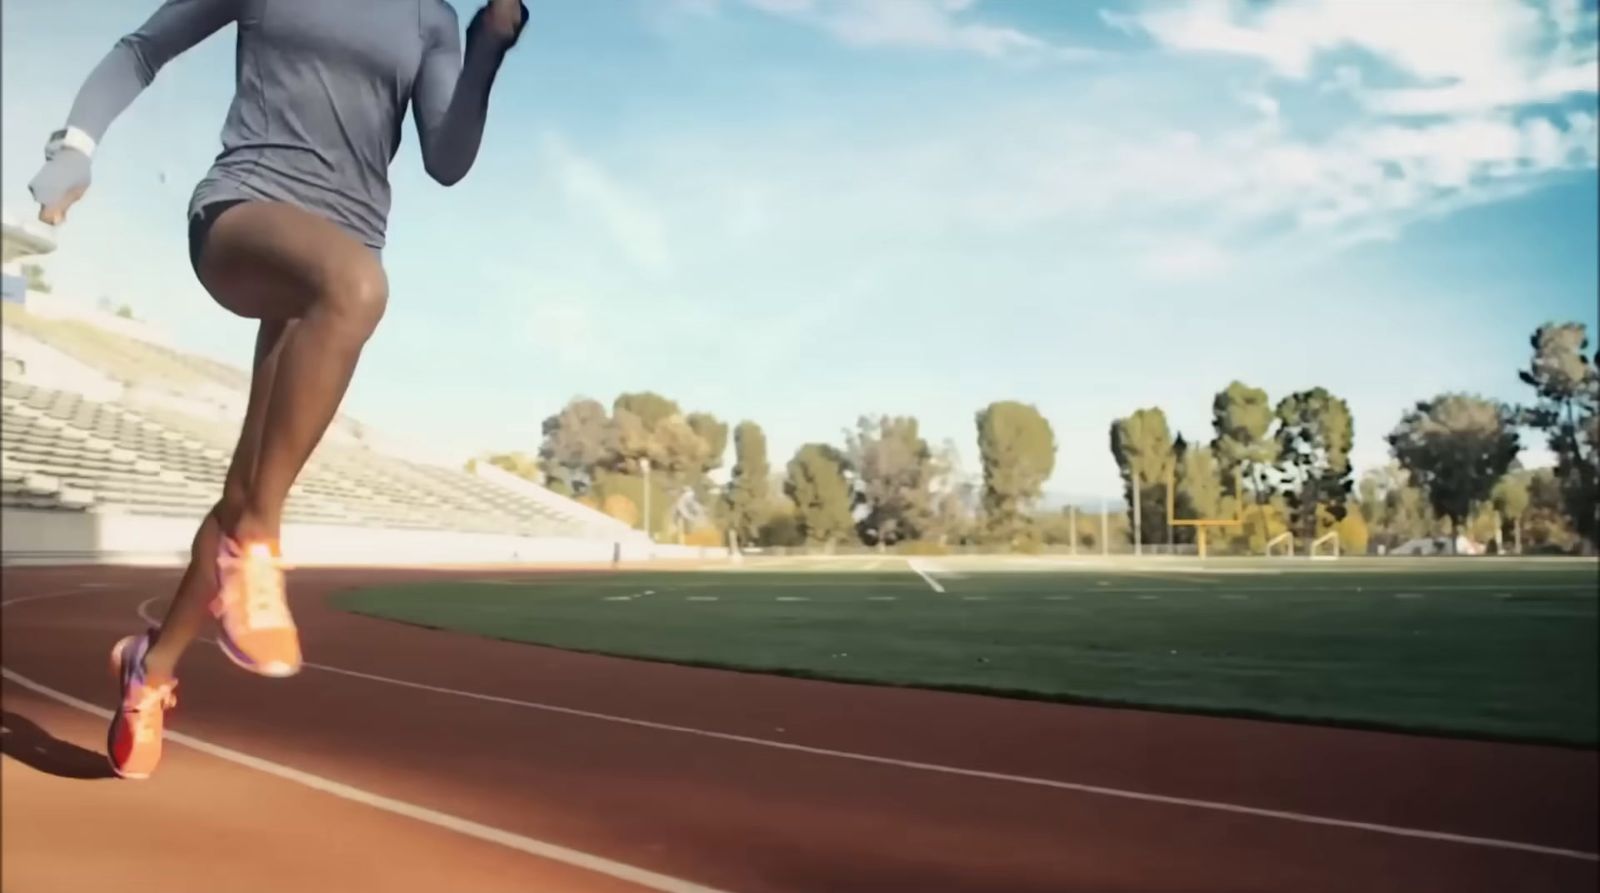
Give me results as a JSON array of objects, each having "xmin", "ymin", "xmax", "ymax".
[{"xmin": 29, "ymin": 0, "xmax": 528, "ymax": 778}]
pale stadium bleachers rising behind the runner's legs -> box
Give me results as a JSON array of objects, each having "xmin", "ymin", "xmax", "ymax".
[{"xmin": 0, "ymin": 304, "xmax": 635, "ymax": 553}]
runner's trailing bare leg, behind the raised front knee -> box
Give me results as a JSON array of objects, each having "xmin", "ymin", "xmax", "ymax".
[{"xmin": 144, "ymin": 320, "xmax": 299, "ymax": 683}]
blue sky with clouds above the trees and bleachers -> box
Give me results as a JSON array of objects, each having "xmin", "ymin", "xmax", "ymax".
[{"xmin": 0, "ymin": 0, "xmax": 1600, "ymax": 496}]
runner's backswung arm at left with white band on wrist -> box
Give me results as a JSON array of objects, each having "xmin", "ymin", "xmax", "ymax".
[{"xmin": 29, "ymin": 0, "xmax": 242, "ymax": 224}]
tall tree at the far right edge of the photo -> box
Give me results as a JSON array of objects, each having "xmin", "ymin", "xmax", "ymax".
[{"xmin": 1518, "ymin": 322, "xmax": 1600, "ymax": 544}]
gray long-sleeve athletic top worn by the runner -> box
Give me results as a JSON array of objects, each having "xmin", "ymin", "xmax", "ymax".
[{"xmin": 50, "ymin": 0, "xmax": 528, "ymax": 250}]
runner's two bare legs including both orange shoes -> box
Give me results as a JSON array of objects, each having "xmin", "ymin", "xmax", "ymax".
[{"xmin": 106, "ymin": 202, "xmax": 389, "ymax": 778}]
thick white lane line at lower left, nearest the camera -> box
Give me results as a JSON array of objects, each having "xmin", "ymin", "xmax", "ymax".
[{"xmin": 0, "ymin": 667, "xmax": 736, "ymax": 893}]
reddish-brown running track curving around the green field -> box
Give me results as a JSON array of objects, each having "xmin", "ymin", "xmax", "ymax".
[{"xmin": 0, "ymin": 568, "xmax": 1600, "ymax": 893}]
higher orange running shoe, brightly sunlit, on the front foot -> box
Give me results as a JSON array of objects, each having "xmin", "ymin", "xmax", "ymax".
[{"xmin": 211, "ymin": 536, "xmax": 301, "ymax": 677}]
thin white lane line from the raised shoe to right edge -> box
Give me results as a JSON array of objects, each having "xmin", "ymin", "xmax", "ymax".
[{"xmin": 118, "ymin": 599, "xmax": 1600, "ymax": 863}]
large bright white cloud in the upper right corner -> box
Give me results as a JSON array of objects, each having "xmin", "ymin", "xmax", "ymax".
[{"xmin": 1062, "ymin": 0, "xmax": 1600, "ymax": 262}]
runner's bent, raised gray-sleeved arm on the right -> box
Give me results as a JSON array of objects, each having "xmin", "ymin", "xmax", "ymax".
[{"xmin": 411, "ymin": 0, "xmax": 528, "ymax": 186}]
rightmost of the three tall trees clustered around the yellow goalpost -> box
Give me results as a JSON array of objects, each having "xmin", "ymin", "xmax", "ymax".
[{"xmin": 1275, "ymin": 387, "xmax": 1355, "ymax": 544}]
